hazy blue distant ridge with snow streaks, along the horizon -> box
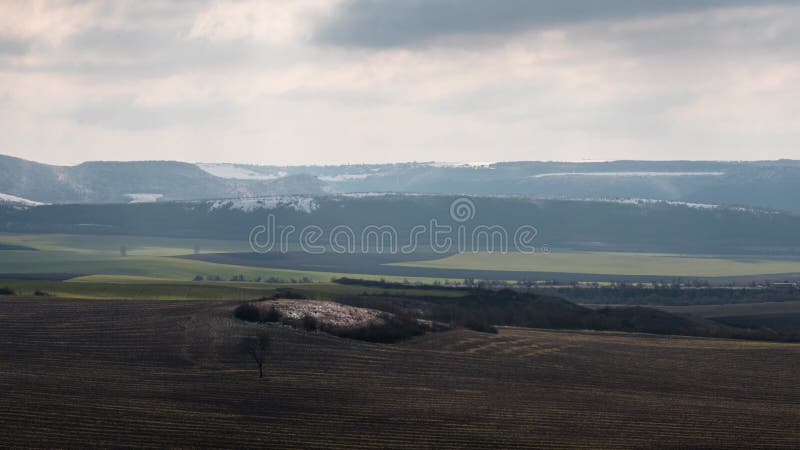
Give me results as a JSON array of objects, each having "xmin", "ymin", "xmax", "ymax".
[{"xmin": 0, "ymin": 156, "xmax": 800, "ymax": 213}]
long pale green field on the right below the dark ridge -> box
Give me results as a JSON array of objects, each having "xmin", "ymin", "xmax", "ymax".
[{"xmin": 394, "ymin": 252, "xmax": 800, "ymax": 277}]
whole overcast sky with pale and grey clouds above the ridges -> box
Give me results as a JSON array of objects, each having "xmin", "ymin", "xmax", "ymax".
[{"xmin": 0, "ymin": 0, "xmax": 800, "ymax": 164}]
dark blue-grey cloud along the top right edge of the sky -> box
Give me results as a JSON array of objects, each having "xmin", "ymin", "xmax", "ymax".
[{"xmin": 316, "ymin": 0, "xmax": 795, "ymax": 48}]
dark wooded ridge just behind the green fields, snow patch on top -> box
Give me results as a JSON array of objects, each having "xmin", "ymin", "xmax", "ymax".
[{"xmin": 0, "ymin": 194, "xmax": 800, "ymax": 257}]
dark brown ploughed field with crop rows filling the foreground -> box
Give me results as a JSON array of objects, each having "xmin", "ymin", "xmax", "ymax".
[{"xmin": 0, "ymin": 298, "xmax": 800, "ymax": 448}]
